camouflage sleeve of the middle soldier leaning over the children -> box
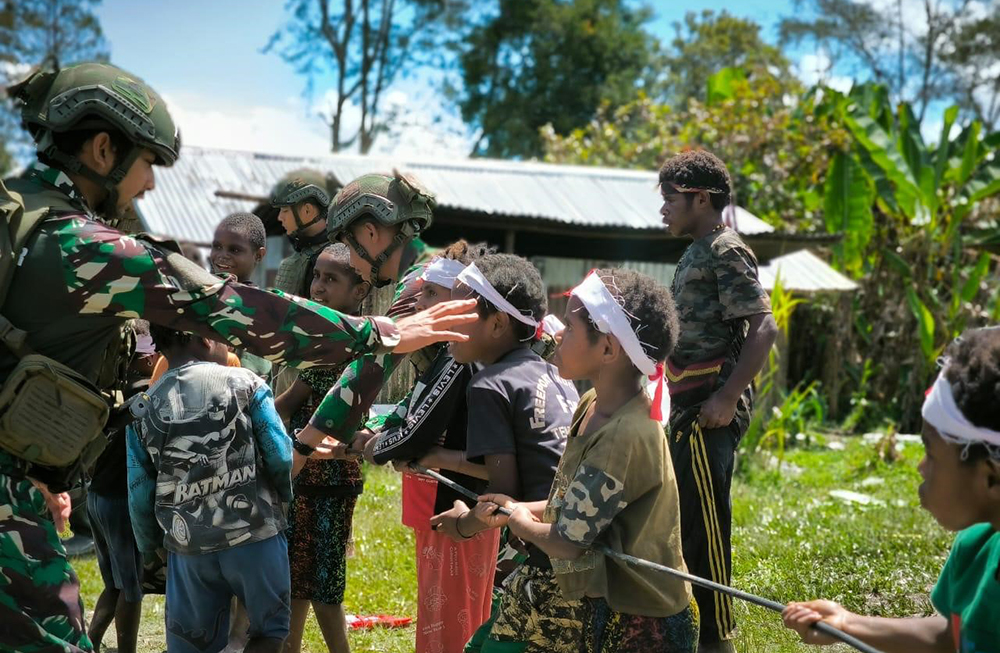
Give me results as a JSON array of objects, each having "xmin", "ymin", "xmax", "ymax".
[{"xmin": 309, "ymin": 269, "xmax": 419, "ymax": 443}]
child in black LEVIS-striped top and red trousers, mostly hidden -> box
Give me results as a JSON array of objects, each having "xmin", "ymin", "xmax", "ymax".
[{"xmin": 364, "ymin": 240, "xmax": 500, "ymax": 653}]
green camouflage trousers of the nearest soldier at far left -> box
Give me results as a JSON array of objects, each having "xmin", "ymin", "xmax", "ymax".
[{"xmin": 0, "ymin": 472, "xmax": 93, "ymax": 653}]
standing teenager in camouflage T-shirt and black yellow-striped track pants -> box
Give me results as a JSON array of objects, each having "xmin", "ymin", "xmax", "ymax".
[{"xmin": 660, "ymin": 150, "xmax": 777, "ymax": 652}]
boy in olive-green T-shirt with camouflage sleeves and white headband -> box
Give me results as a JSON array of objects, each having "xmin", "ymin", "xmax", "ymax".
[{"xmin": 476, "ymin": 269, "xmax": 699, "ymax": 653}]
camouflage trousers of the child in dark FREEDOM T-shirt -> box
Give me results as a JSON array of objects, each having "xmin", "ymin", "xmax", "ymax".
[{"xmin": 482, "ymin": 564, "xmax": 583, "ymax": 653}]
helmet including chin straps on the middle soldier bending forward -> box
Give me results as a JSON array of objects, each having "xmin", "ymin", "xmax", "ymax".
[{"xmin": 326, "ymin": 171, "xmax": 435, "ymax": 287}]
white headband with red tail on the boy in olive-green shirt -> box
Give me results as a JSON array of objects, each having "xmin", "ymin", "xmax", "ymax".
[{"xmin": 570, "ymin": 272, "xmax": 670, "ymax": 422}]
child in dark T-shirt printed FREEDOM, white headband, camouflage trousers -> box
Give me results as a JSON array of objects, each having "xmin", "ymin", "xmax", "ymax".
[{"xmin": 420, "ymin": 254, "xmax": 582, "ymax": 653}]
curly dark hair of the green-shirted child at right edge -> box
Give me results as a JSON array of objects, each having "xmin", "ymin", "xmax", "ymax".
[{"xmin": 945, "ymin": 327, "xmax": 1000, "ymax": 462}]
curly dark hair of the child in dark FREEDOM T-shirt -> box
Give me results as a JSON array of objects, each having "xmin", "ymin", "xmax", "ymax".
[{"xmin": 476, "ymin": 254, "xmax": 549, "ymax": 341}]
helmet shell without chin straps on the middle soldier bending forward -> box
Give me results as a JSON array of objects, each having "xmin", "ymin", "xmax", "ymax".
[{"xmin": 326, "ymin": 171, "xmax": 435, "ymax": 241}]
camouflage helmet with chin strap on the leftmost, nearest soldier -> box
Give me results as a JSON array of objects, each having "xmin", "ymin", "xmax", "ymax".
[{"xmin": 8, "ymin": 63, "xmax": 181, "ymax": 224}]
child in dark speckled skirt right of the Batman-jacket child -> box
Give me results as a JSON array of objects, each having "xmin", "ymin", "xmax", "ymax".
[{"xmin": 276, "ymin": 243, "xmax": 370, "ymax": 652}]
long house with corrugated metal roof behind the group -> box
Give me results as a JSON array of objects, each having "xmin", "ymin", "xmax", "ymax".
[{"xmin": 137, "ymin": 146, "xmax": 856, "ymax": 404}]
